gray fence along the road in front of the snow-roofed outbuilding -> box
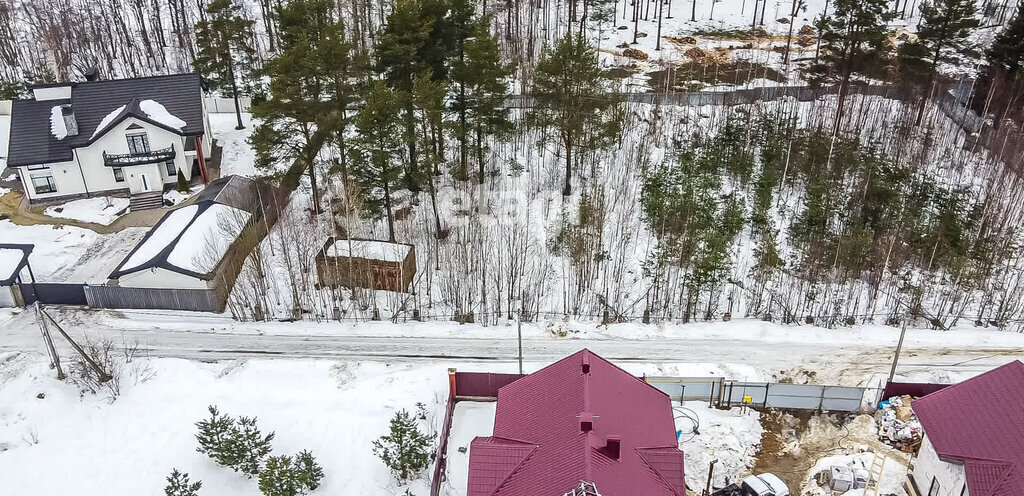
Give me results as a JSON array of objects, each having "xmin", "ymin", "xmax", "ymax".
[{"xmin": 85, "ymin": 286, "xmax": 221, "ymax": 312}]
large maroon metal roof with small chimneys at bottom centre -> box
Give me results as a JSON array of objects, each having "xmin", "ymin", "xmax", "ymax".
[{"xmin": 468, "ymin": 349, "xmax": 686, "ymax": 496}]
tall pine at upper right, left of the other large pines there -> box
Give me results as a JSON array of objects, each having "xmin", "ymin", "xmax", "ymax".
[{"xmin": 812, "ymin": 0, "xmax": 895, "ymax": 133}]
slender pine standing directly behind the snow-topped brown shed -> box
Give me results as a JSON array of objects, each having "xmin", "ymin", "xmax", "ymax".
[{"xmin": 349, "ymin": 81, "xmax": 403, "ymax": 241}]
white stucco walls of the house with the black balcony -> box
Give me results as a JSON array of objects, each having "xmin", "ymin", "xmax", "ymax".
[{"xmin": 20, "ymin": 118, "xmax": 196, "ymax": 200}]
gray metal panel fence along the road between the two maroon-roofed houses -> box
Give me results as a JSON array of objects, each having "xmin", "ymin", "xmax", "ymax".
[{"xmin": 644, "ymin": 376, "xmax": 878, "ymax": 412}]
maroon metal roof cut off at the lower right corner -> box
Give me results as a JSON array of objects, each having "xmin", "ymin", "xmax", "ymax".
[{"xmin": 913, "ymin": 361, "xmax": 1024, "ymax": 496}]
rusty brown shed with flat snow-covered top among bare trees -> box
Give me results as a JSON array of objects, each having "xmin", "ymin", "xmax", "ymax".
[{"xmin": 316, "ymin": 237, "xmax": 416, "ymax": 293}]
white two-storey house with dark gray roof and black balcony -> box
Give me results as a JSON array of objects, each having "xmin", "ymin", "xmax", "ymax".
[{"xmin": 7, "ymin": 74, "xmax": 212, "ymax": 209}]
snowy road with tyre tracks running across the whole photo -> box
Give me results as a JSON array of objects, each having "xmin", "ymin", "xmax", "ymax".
[{"xmin": 0, "ymin": 308, "xmax": 1024, "ymax": 385}]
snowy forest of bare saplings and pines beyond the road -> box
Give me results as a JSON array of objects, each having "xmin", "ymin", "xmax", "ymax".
[{"xmin": 6, "ymin": 0, "xmax": 1024, "ymax": 328}]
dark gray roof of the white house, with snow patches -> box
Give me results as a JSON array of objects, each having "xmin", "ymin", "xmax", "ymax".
[{"xmin": 7, "ymin": 74, "xmax": 204, "ymax": 166}]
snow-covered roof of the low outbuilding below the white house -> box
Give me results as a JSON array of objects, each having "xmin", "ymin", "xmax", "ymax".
[{"xmin": 111, "ymin": 202, "xmax": 252, "ymax": 279}]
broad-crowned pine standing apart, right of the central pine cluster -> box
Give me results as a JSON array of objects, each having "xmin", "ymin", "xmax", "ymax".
[{"xmin": 528, "ymin": 36, "xmax": 621, "ymax": 196}]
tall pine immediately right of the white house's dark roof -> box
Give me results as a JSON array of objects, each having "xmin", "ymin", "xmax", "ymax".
[{"xmin": 193, "ymin": 0, "xmax": 256, "ymax": 129}]
